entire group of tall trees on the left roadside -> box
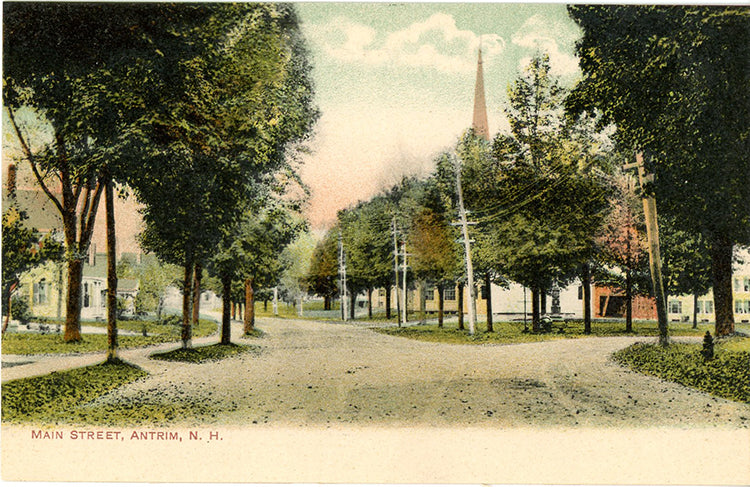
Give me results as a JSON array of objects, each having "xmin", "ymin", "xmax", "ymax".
[{"xmin": 3, "ymin": 2, "xmax": 317, "ymax": 357}]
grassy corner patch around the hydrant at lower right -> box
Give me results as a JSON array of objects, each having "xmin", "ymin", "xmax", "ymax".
[{"xmin": 614, "ymin": 338, "xmax": 750, "ymax": 403}]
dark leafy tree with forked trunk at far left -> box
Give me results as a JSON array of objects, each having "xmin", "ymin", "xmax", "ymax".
[{"xmin": 3, "ymin": 3, "xmax": 178, "ymax": 341}]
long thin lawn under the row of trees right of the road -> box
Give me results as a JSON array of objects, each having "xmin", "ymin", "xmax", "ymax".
[{"xmin": 372, "ymin": 321, "xmax": 713, "ymax": 344}]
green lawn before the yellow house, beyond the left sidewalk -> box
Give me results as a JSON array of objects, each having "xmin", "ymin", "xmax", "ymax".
[{"xmin": 2, "ymin": 320, "xmax": 218, "ymax": 355}]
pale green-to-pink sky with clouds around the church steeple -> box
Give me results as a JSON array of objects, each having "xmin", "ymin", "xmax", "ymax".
[{"xmin": 297, "ymin": 2, "xmax": 580, "ymax": 230}]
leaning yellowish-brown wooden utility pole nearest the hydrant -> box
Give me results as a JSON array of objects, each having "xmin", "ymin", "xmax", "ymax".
[{"xmin": 623, "ymin": 152, "xmax": 669, "ymax": 346}]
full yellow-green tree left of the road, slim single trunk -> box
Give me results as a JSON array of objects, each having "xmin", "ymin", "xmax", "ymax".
[{"xmin": 131, "ymin": 4, "xmax": 317, "ymax": 347}]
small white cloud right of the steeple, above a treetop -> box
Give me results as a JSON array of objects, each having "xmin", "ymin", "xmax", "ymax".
[{"xmin": 511, "ymin": 15, "xmax": 579, "ymax": 76}]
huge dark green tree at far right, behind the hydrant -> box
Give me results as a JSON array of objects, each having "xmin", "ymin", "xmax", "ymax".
[{"xmin": 569, "ymin": 5, "xmax": 750, "ymax": 336}]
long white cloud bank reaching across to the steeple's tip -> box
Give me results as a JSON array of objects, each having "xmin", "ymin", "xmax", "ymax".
[{"xmin": 310, "ymin": 13, "xmax": 505, "ymax": 73}]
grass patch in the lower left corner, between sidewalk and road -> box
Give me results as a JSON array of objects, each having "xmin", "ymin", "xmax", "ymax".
[{"xmin": 2, "ymin": 361, "xmax": 148, "ymax": 423}]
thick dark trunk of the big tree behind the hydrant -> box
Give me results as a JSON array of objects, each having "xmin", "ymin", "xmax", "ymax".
[{"xmin": 711, "ymin": 237, "xmax": 734, "ymax": 337}]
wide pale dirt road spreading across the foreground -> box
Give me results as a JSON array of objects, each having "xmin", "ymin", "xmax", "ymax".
[{"xmin": 85, "ymin": 320, "xmax": 750, "ymax": 428}]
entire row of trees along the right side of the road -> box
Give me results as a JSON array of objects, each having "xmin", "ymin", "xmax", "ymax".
[{"xmin": 309, "ymin": 6, "xmax": 750, "ymax": 343}]
